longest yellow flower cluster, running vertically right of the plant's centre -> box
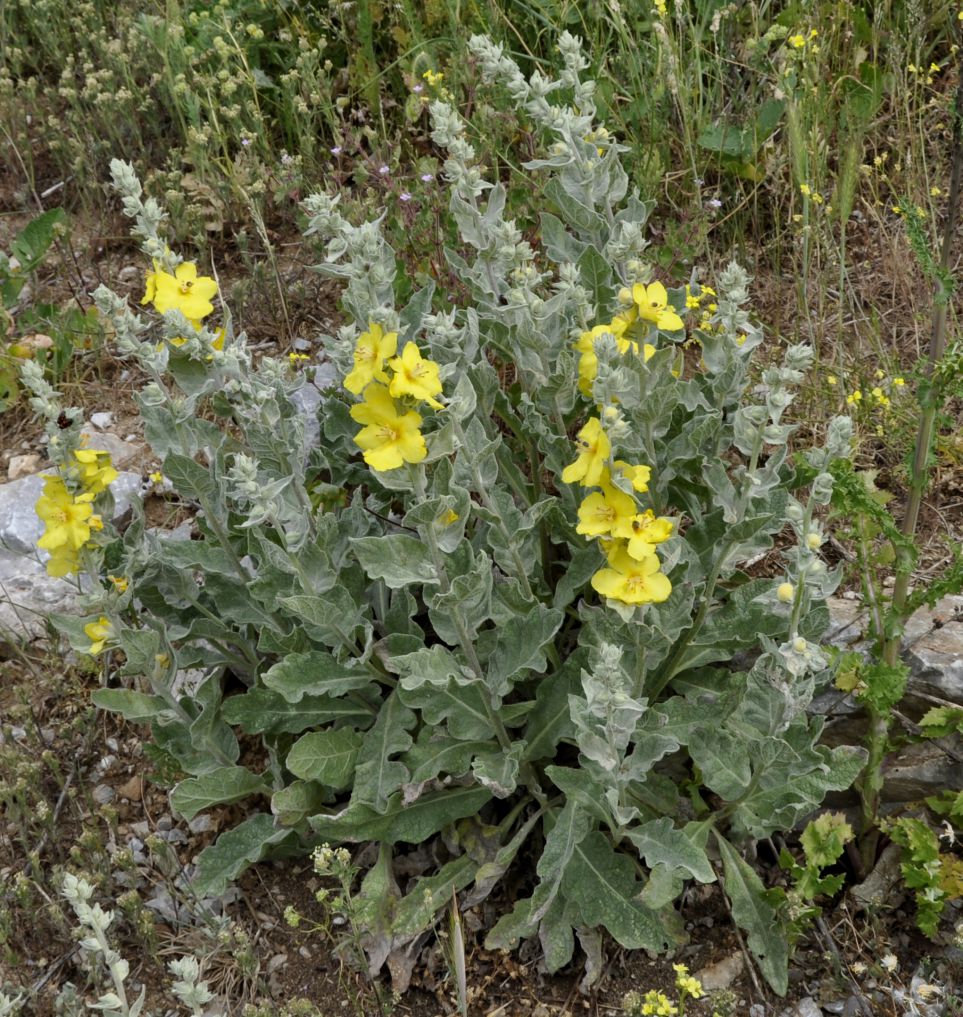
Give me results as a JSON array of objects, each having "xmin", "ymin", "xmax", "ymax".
[{"xmin": 561, "ymin": 417, "xmax": 673, "ymax": 604}]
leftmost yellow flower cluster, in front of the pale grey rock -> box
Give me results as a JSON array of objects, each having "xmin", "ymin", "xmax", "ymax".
[{"xmin": 35, "ymin": 448, "xmax": 117, "ymax": 577}]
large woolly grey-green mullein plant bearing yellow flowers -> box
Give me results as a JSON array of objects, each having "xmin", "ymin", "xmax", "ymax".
[{"xmin": 35, "ymin": 29, "xmax": 863, "ymax": 992}]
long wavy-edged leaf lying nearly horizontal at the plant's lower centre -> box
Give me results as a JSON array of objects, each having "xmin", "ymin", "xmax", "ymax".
[{"xmin": 308, "ymin": 787, "xmax": 491, "ymax": 844}]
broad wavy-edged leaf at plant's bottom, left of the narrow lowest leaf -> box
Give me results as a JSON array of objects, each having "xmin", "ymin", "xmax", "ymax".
[{"xmin": 562, "ymin": 831, "xmax": 677, "ymax": 952}]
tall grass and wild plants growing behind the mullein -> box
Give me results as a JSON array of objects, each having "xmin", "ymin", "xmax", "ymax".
[{"xmin": 0, "ymin": 0, "xmax": 963, "ymax": 451}]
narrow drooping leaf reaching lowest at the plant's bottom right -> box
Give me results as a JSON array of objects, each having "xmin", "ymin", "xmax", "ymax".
[{"xmin": 716, "ymin": 834, "xmax": 789, "ymax": 996}]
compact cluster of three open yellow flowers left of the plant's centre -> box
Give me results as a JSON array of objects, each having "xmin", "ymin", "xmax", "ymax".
[{"xmin": 345, "ymin": 322, "xmax": 444, "ymax": 472}]
